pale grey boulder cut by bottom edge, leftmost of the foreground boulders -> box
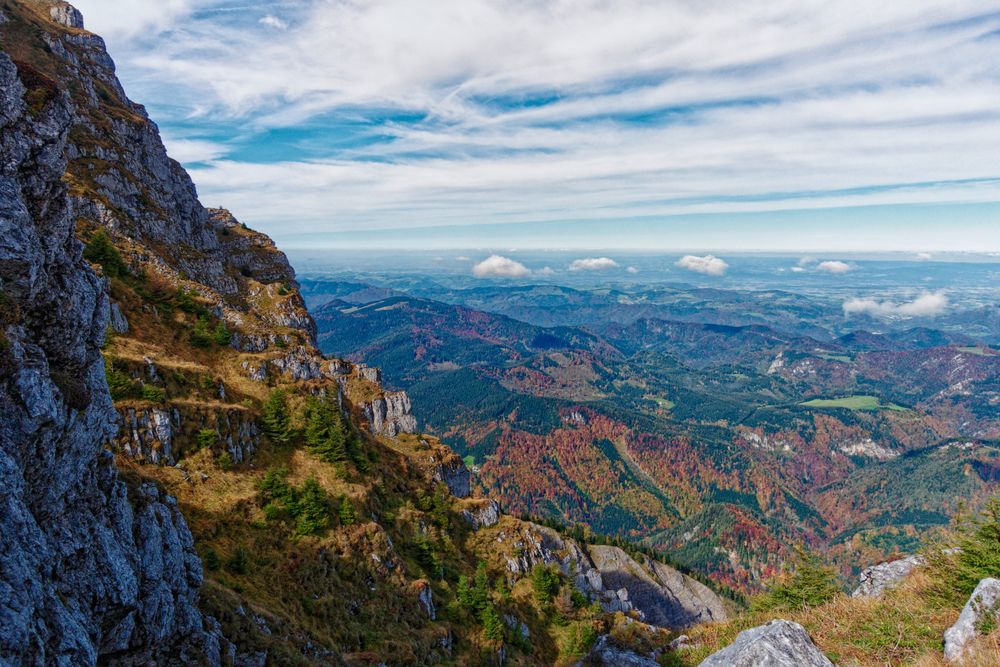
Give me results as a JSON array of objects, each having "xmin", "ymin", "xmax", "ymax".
[{"xmin": 701, "ymin": 619, "xmax": 833, "ymax": 667}]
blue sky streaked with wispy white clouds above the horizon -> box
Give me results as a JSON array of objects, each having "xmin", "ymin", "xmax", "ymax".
[{"xmin": 75, "ymin": 0, "xmax": 1000, "ymax": 252}]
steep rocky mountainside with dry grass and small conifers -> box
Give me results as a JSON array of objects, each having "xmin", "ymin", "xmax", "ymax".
[{"xmin": 0, "ymin": 0, "xmax": 727, "ymax": 665}]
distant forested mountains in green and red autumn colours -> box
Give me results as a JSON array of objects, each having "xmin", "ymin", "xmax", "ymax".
[{"xmin": 302, "ymin": 279, "xmax": 1000, "ymax": 589}]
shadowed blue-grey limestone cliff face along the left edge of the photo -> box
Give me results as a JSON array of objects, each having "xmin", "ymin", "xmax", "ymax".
[{"xmin": 0, "ymin": 44, "xmax": 223, "ymax": 665}]
